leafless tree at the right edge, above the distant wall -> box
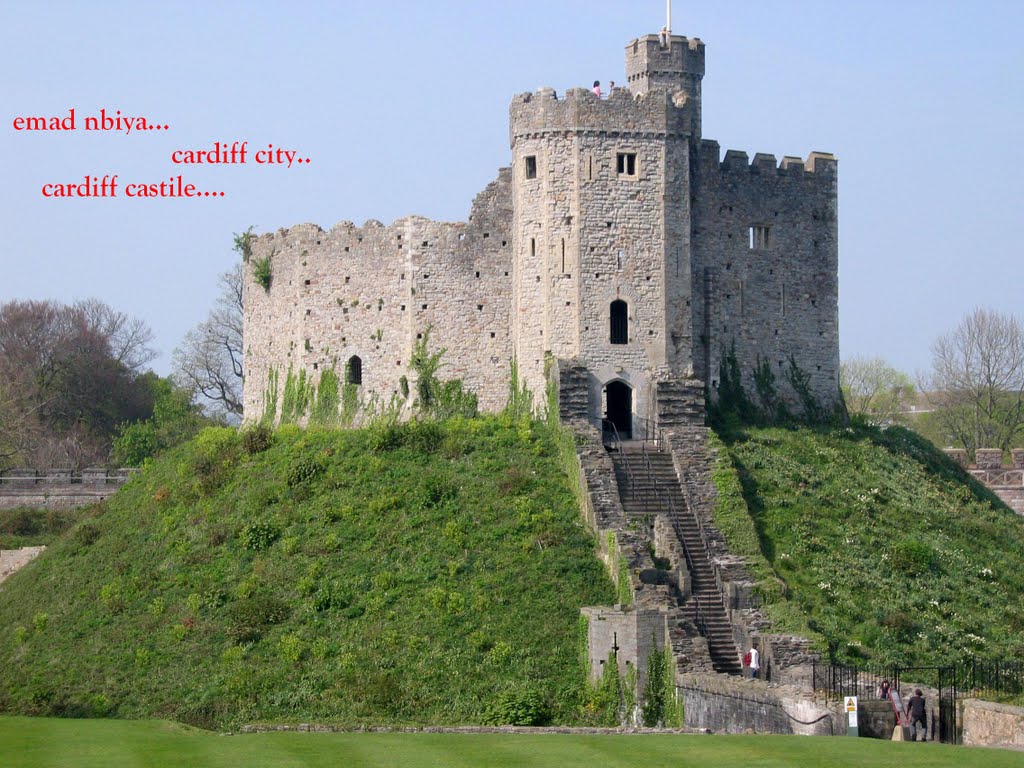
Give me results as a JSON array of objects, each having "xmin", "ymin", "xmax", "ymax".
[{"xmin": 928, "ymin": 308, "xmax": 1024, "ymax": 456}]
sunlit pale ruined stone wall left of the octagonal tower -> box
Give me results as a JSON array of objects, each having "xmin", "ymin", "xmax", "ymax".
[{"xmin": 244, "ymin": 170, "xmax": 511, "ymax": 419}]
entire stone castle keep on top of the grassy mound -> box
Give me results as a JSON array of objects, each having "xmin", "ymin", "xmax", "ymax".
[{"xmin": 244, "ymin": 35, "xmax": 839, "ymax": 436}]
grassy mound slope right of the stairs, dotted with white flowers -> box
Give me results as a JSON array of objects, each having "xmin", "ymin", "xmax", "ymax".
[{"xmin": 714, "ymin": 428, "xmax": 1024, "ymax": 665}]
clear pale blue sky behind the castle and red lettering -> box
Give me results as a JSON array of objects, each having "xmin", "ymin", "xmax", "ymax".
[{"xmin": 0, "ymin": 0, "xmax": 1024, "ymax": 373}]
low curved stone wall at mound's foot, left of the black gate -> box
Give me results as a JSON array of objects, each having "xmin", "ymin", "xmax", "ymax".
[{"xmin": 679, "ymin": 675, "xmax": 846, "ymax": 736}]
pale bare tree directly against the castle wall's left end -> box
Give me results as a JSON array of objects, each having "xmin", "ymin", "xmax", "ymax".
[{"xmin": 173, "ymin": 262, "xmax": 243, "ymax": 417}]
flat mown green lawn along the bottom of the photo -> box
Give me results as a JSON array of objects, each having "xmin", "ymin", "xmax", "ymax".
[{"xmin": 0, "ymin": 718, "xmax": 1024, "ymax": 768}]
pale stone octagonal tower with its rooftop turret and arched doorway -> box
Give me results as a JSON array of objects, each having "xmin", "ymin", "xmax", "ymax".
[{"xmin": 510, "ymin": 36, "xmax": 703, "ymax": 434}]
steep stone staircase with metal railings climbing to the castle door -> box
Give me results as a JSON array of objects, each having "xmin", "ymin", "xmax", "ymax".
[{"xmin": 611, "ymin": 442, "xmax": 743, "ymax": 675}]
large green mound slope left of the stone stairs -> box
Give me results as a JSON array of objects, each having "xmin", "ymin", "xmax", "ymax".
[{"xmin": 0, "ymin": 419, "xmax": 613, "ymax": 728}]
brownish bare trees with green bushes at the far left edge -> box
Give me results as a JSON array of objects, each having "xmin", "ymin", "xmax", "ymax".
[{"xmin": 0, "ymin": 299, "xmax": 202, "ymax": 470}]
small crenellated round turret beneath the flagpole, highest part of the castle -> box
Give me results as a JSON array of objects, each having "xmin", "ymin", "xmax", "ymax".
[{"xmin": 626, "ymin": 35, "xmax": 705, "ymax": 138}]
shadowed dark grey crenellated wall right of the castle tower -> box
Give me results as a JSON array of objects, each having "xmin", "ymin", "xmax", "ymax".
[{"xmin": 693, "ymin": 140, "xmax": 839, "ymax": 408}]
